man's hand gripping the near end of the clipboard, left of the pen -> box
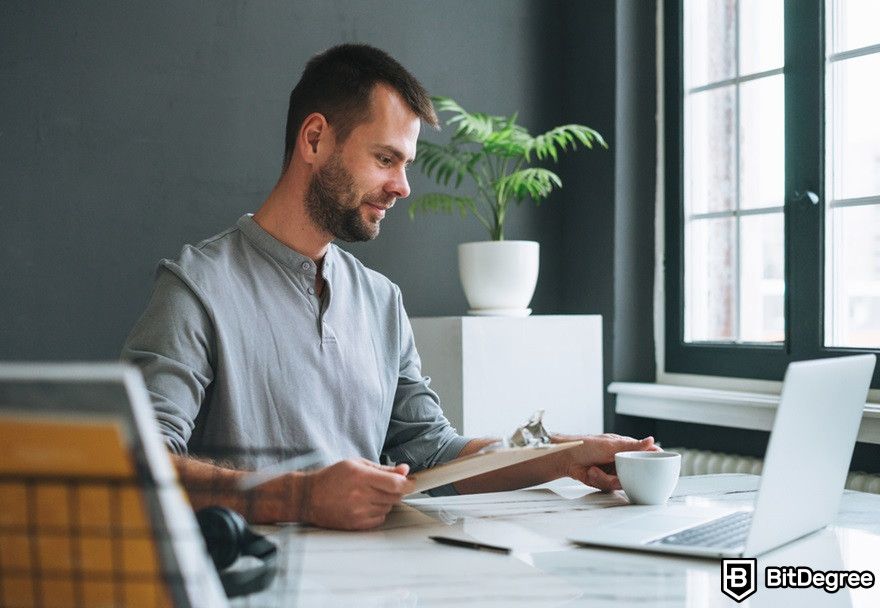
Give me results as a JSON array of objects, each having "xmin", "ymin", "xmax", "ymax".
[{"xmin": 300, "ymin": 458, "xmax": 415, "ymax": 530}]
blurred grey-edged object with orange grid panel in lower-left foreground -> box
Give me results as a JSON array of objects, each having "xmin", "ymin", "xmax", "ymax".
[{"xmin": 0, "ymin": 363, "xmax": 229, "ymax": 607}]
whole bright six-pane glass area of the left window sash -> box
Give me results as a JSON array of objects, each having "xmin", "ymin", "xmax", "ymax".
[{"xmin": 683, "ymin": 0, "xmax": 784, "ymax": 342}]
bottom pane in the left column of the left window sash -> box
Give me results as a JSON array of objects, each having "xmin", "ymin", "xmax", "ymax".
[{"xmin": 684, "ymin": 217, "xmax": 736, "ymax": 342}]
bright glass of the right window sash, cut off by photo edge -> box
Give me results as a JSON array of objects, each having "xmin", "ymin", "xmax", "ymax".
[{"xmin": 825, "ymin": 0, "xmax": 880, "ymax": 348}]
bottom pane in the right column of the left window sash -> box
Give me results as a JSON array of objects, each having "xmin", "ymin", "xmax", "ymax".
[{"xmin": 739, "ymin": 212, "xmax": 785, "ymax": 342}]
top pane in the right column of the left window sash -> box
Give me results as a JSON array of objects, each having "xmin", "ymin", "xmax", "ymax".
[{"xmin": 739, "ymin": 0, "xmax": 784, "ymax": 76}]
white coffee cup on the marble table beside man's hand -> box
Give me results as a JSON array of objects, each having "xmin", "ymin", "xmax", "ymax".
[{"xmin": 614, "ymin": 452, "xmax": 681, "ymax": 505}]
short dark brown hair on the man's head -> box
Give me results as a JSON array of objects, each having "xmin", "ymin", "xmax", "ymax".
[{"xmin": 284, "ymin": 44, "xmax": 440, "ymax": 169}]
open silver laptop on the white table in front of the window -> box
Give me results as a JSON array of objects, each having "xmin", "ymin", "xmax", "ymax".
[{"xmin": 570, "ymin": 355, "xmax": 876, "ymax": 558}]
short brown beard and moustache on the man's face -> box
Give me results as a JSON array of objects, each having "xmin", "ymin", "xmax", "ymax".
[{"xmin": 306, "ymin": 153, "xmax": 390, "ymax": 243}]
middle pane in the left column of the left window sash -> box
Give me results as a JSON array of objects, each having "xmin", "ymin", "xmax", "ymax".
[{"xmin": 684, "ymin": 86, "xmax": 736, "ymax": 214}]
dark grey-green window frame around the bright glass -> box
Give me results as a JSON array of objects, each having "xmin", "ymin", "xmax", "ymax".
[{"xmin": 663, "ymin": 0, "xmax": 880, "ymax": 388}]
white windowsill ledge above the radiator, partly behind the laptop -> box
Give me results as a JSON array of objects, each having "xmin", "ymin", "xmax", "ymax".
[{"xmin": 608, "ymin": 382, "xmax": 880, "ymax": 443}]
